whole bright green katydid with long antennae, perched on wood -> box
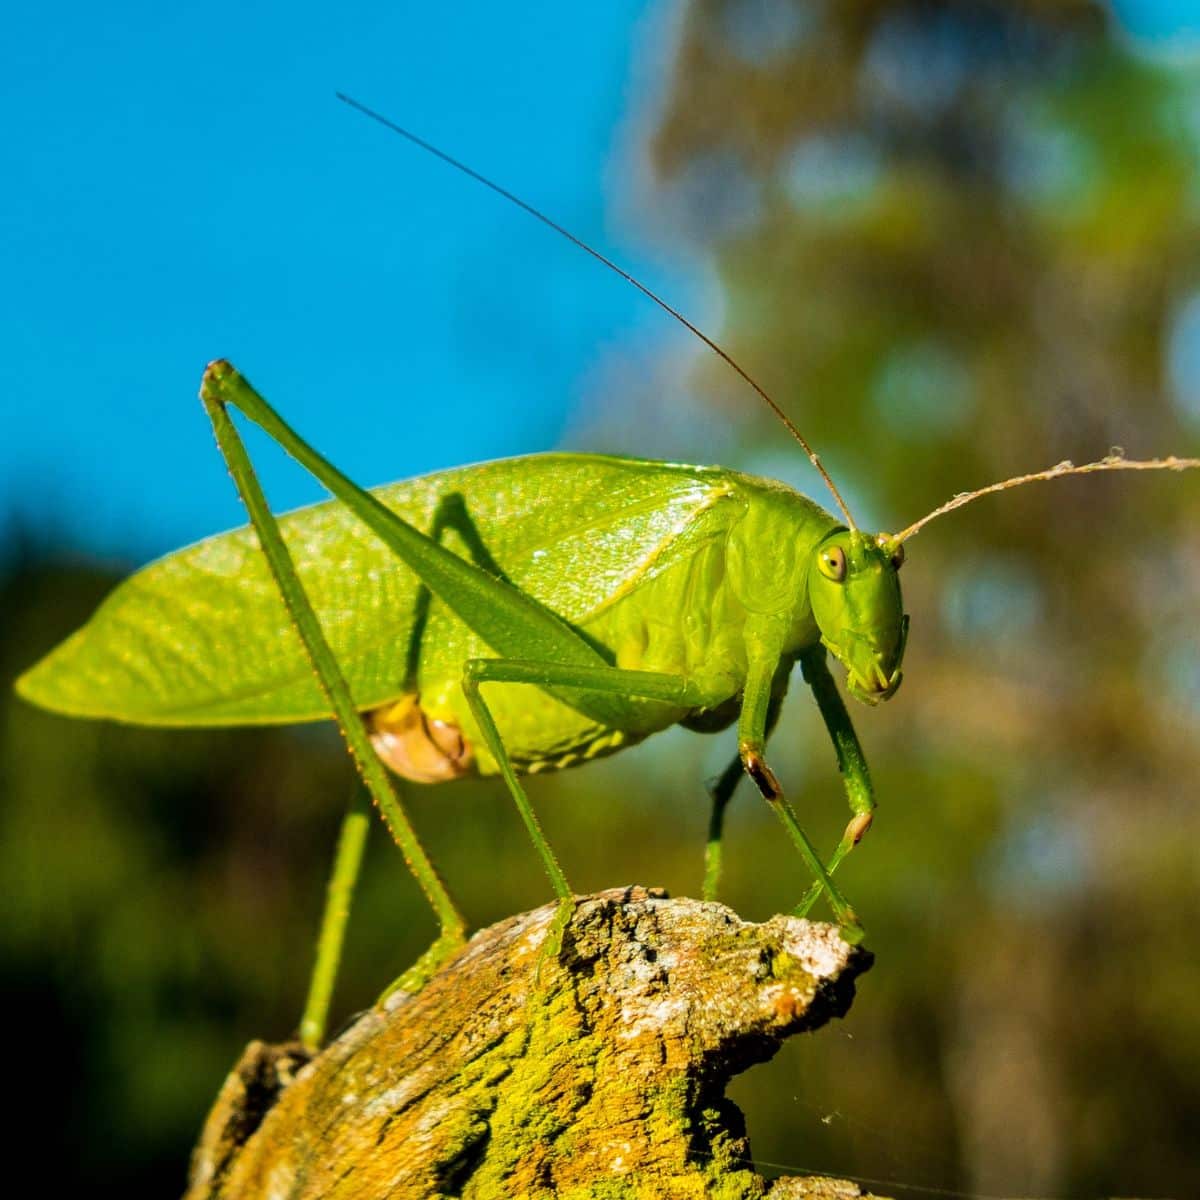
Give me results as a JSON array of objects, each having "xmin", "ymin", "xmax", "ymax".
[{"xmin": 18, "ymin": 102, "xmax": 1200, "ymax": 1045}]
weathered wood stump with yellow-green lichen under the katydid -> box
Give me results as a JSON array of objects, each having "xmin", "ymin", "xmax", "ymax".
[{"xmin": 187, "ymin": 888, "xmax": 871, "ymax": 1200}]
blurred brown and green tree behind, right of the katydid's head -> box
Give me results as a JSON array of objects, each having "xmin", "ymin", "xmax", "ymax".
[{"xmin": 619, "ymin": 0, "xmax": 1200, "ymax": 1194}]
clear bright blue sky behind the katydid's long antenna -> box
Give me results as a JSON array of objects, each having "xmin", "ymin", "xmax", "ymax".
[{"xmin": 0, "ymin": 0, "xmax": 1194, "ymax": 559}]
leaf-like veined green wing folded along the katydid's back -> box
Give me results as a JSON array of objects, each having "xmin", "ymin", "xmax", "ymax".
[{"xmin": 17, "ymin": 454, "xmax": 739, "ymax": 726}]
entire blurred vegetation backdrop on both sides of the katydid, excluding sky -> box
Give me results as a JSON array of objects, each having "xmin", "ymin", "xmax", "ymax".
[{"xmin": 0, "ymin": 0, "xmax": 1200, "ymax": 1196}]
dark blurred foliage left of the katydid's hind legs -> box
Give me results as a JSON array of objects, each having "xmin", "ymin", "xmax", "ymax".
[{"xmin": 0, "ymin": 535, "xmax": 346, "ymax": 1196}]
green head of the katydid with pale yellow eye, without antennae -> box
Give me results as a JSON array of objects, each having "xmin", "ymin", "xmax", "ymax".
[{"xmin": 809, "ymin": 529, "xmax": 908, "ymax": 704}]
